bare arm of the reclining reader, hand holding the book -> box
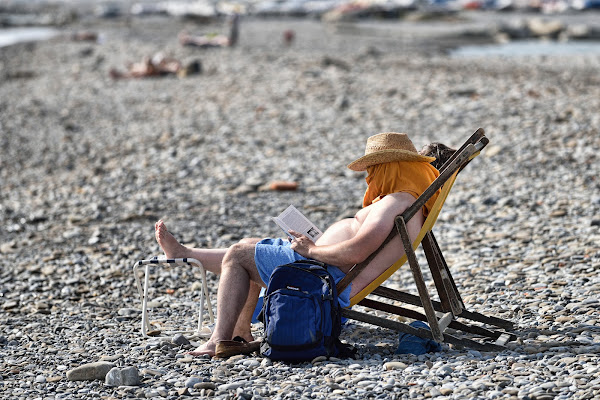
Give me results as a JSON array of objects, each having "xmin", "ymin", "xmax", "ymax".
[{"xmin": 292, "ymin": 193, "xmax": 423, "ymax": 272}]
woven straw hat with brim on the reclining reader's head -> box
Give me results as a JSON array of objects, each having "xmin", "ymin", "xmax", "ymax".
[{"xmin": 348, "ymin": 132, "xmax": 435, "ymax": 171}]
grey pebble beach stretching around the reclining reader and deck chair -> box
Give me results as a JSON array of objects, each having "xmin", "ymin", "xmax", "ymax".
[{"xmin": 0, "ymin": 5, "xmax": 600, "ymax": 400}]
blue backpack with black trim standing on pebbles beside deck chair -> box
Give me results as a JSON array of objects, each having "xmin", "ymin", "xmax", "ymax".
[{"xmin": 259, "ymin": 260, "xmax": 353, "ymax": 362}]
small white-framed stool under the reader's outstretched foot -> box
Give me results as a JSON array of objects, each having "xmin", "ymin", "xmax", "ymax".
[{"xmin": 133, "ymin": 257, "xmax": 215, "ymax": 338}]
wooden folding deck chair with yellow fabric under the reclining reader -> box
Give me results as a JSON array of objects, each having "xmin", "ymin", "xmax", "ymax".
[{"xmin": 337, "ymin": 128, "xmax": 515, "ymax": 351}]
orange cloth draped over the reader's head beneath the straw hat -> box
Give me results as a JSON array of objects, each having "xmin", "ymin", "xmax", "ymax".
[{"xmin": 363, "ymin": 161, "xmax": 440, "ymax": 216}]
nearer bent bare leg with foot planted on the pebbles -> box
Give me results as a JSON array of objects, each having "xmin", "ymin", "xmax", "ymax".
[{"xmin": 190, "ymin": 243, "xmax": 262, "ymax": 356}]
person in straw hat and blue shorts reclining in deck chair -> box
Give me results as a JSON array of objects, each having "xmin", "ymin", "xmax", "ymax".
[{"xmin": 155, "ymin": 132, "xmax": 452, "ymax": 356}]
